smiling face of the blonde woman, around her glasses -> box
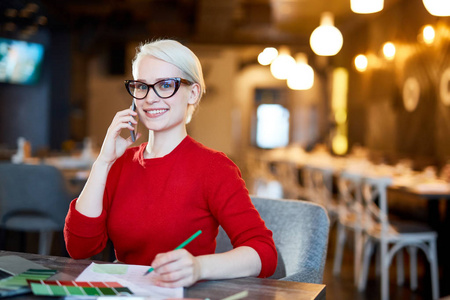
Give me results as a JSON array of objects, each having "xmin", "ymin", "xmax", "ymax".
[{"xmin": 134, "ymin": 56, "xmax": 197, "ymax": 133}]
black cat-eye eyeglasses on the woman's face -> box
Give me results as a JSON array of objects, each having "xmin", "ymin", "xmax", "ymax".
[{"xmin": 125, "ymin": 77, "xmax": 192, "ymax": 100}]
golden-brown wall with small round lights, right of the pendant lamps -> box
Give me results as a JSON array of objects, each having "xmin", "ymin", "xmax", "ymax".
[{"xmin": 343, "ymin": 0, "xmax": 450, "ymax": 167}]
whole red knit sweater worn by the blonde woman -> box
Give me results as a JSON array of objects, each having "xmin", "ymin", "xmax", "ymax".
[{"xmin": 64, "ymin": 136, "xmax": 277, "ymax": 277}]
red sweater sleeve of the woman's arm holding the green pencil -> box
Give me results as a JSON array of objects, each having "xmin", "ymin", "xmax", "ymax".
[{"xmin": 205, "ymin": 153, "xmax": 277, "ymax": 277}]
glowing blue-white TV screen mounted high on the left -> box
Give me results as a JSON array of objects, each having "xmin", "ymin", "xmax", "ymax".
[{"xmin": 0, "ymin": 38, "xmax": 44, "ymax": 84}]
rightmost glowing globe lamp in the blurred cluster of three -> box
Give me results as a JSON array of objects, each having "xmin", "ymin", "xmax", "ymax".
[{"xmin": 287, "ymin": 53, "xmax": 314, "ymax": 90}]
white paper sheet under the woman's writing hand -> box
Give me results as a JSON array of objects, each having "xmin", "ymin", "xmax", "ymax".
[{"xmin": 75, "ymin": 263, "xmax": 183, "ymax": 299}]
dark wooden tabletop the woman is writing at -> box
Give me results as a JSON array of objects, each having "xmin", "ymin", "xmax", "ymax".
[{"xmin": 0, "ymin": 251, "xmax": 326, "ymax": 300}]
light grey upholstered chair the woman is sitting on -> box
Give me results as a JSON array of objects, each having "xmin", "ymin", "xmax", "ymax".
[{"xmin": 216, "ymin": 196, "xmax": 330, "ymax": 283}]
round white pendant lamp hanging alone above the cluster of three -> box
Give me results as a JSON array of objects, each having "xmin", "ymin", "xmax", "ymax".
[{"xmin": 309, "ymin": 12, "xmax": 344, "ymax": 56}]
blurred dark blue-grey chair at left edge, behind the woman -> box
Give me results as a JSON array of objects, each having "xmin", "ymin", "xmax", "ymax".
[{"xmin": 0, "ymin": 163, "xmax": 71, "ymax": 254}]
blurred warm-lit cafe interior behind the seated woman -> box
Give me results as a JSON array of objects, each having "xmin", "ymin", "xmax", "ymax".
[{"xmin": 0, "ymin": 0, "xmax": 450, "ymax": 299}]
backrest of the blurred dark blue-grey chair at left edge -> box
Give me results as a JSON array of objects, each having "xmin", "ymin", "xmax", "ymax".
[{"xmin": 0, "ymin": 163, "xmax": 70, "ymax": 230}]
